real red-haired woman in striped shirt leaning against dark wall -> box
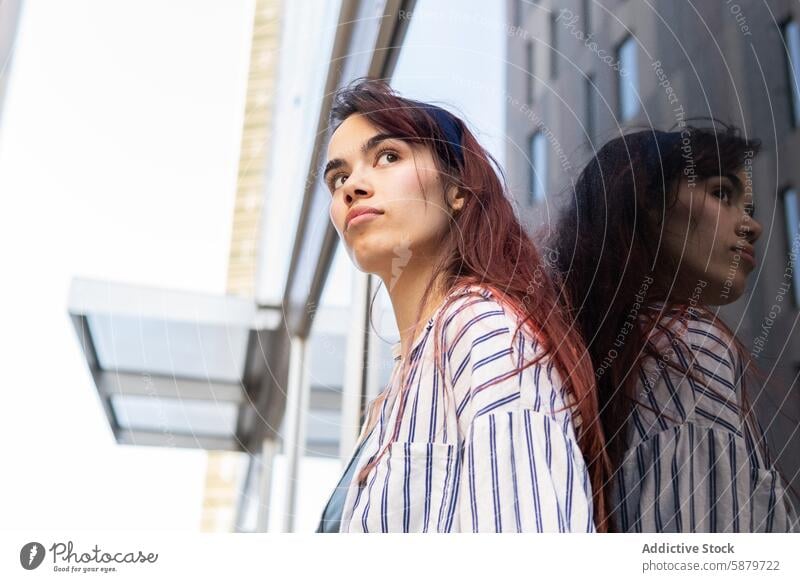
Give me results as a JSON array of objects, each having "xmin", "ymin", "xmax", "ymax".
[{"xmin": 318, "ymin": 81, "xmax": 607, "ymax": 532}]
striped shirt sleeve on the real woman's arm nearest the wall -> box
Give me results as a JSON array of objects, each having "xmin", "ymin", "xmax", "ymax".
[{"xmin": 444, "ymin": 297, "xmax": 594, "ymax": 532}]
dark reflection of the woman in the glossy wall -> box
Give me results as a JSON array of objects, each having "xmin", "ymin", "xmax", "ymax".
[{"xmin": 555, "ymin": 127, "xmax": 796, "ymax": 532}]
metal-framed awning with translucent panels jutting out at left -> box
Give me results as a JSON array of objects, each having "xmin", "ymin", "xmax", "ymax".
[{"xmin": 68, "ymin": 279, "xmax": 284, "ymax": 451}]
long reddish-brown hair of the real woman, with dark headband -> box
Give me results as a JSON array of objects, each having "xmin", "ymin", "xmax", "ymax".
[{"xmin": 331, "ymin": 79, "xmax": 610, "ymax": 531}]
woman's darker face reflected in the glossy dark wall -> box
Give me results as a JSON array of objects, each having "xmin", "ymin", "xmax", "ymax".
[{"xmin": 663, "ymin": 169, "xmax": 762, "ymax": 305}]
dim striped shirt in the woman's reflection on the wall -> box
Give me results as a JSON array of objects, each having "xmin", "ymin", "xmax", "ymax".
[{"xmin": 611, "ymin": 307, "xmax": 798, "ymax": 532}]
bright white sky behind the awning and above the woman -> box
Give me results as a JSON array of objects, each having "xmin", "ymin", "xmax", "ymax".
[{"xmin": 0, "ymin": 0, "xmax": 505, "ymax": 531}]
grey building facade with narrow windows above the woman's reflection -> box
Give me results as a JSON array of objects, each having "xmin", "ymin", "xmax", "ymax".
[{"xmin": 506, "ymin": 0, "xmax": 800, "ymax": 502}]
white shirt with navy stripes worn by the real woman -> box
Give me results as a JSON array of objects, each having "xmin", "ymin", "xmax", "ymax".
[{"xmin": 328, "ymin": 285, "xmax": 594, "ymax": 532}]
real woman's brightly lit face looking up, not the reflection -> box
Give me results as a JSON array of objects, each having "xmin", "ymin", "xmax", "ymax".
[{"xmin": 324, "ymin": 114, "xmax": 460, "ymax": 281}]
